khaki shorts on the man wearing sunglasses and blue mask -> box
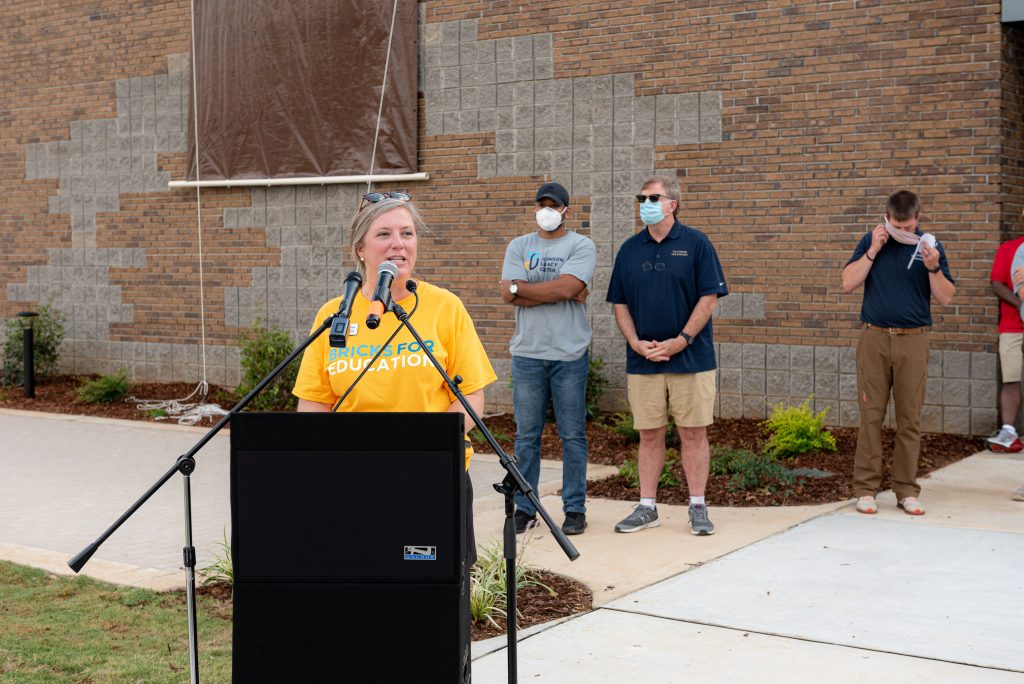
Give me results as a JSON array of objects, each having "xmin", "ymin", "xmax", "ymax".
[{"xmin": 626, "ymin": 371, "xmax": 718, "ymax": 430}]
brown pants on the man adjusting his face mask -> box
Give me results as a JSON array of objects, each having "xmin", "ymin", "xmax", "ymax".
[{"xmin": 853, "ymin": 328, "xmax": 928, "ymax": 501}]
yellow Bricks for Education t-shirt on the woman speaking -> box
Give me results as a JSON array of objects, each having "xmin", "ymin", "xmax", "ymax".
[{"xmin": 292, "ymin": 281, "xmax": 498, "ymax": 468}]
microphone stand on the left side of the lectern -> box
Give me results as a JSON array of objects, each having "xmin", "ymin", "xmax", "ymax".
[{"xmin": 68, "ymin": 300, "xmax": 345, "ymax": 684}]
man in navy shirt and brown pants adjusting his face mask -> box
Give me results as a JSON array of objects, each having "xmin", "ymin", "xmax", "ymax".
[{"xmin": 843, "ymin": 190, "xmax": 956, "ymax": 515}]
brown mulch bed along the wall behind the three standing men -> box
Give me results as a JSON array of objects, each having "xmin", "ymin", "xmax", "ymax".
[{"xmin": 475, "ymin": 414, "xmax": 985, "ymax": 506}]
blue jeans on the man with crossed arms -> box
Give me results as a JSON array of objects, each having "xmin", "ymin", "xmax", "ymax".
[{"xmin": 512, "ymin": 353, "xmax": 590, "ymax": 514}]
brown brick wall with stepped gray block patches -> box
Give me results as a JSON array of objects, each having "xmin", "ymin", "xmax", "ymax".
[{"xmin": 0, "ymin": 0, "xmax": 1024, "ymax": 433}]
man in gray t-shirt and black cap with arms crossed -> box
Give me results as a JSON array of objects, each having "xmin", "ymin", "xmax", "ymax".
[{"xmin": 501, "ymin": 183, "xmax": 597, "ymax": 535}]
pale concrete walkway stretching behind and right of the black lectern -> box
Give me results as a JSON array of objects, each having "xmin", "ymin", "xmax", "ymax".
[{"xmin": 0, "ymin": 410, "xmax": 1024, "ymax": 684}]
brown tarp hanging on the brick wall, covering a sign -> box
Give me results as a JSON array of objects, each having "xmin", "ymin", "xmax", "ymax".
[{"xmin": 188, "ymin": 0, "xmax": 418, "ymax": 180}]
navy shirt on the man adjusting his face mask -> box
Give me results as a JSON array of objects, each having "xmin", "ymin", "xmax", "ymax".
[{"xmin": 846, "ymin": 228, "xmax": 956, "ymax": 328}]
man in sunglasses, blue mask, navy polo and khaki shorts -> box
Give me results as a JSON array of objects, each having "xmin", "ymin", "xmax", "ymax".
[{"xmin": 607, "ymin": 176, "xmax": 729, "ymax": 536}]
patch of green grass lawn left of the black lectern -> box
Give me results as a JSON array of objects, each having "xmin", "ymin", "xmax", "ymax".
[{"xmin": 0, "ymin": 561, "xmax": 231, "ymax": 684}]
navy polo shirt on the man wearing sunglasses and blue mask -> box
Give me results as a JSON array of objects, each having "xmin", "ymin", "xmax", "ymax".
[{"xmin": 607, "ymin": 221, "xmax": 729, "ymax": 375}]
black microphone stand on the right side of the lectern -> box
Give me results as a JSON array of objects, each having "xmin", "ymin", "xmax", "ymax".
[{"xmin": 387, "ymin": 281, "xmax": 580, "ymax": 684}]
